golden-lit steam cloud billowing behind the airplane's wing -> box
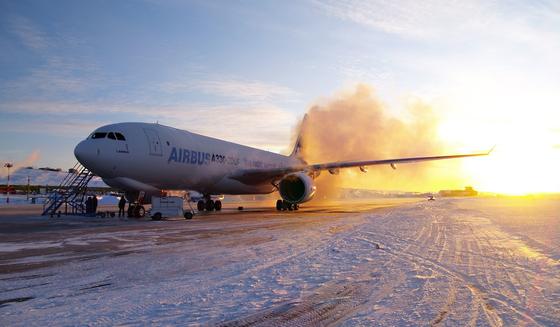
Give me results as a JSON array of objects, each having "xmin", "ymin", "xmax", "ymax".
[{"xmin": 302, "ymin": 84, "xmax": 463, "ymax": 200}]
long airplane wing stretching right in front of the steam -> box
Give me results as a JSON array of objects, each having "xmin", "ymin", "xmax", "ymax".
[{"xmin": 229, "ymin": 148, "xmax": 494, "ymax": 185}]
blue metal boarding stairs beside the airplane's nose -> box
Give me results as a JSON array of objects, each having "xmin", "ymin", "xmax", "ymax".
[{"xmin": 42, "ymin": 163, "xmax": 94, "ymax": 217}]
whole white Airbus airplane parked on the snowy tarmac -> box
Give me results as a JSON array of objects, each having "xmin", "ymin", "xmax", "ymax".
[{"xmin": 74, "ymin": 118, "xmax": 492, "ymax": 219}]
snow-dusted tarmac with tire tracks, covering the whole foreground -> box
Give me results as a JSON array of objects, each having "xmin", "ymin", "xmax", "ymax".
[{"xmin": 0, "ymin": 199, "xmax": 560, "ymax": 326}]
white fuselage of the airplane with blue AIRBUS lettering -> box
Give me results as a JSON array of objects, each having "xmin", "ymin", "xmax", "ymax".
[{"xmin": 74, "ymin": 123, "xmax": 301, "ymax": 195}]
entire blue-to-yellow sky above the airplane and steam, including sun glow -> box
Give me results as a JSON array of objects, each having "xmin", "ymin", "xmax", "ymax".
[{"xmin": 0, "ymin": 0, "xmax": 560, "ymax": 192}]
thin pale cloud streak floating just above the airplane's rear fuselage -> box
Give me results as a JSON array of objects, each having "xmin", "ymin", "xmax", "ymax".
[{"xmin": 161, "ymin": 77, "xmax": 298, "ymax": 101}]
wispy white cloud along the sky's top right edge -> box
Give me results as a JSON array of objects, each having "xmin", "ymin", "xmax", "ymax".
[{"xmin": 314, "ymin": 0, "xmax": 558, "ymax": 41}]
